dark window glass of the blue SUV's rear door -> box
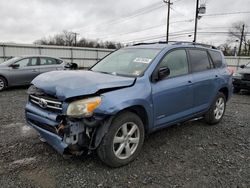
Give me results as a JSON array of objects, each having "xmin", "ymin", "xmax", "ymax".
[{"xmin": 189, "ymin": 49, "xmax": 211, "ymax": 72}]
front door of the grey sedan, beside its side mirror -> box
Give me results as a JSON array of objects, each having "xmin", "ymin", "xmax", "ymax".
[{"xmin": 10, "ymin": 57, "xmax": 39, "ymax": 85}]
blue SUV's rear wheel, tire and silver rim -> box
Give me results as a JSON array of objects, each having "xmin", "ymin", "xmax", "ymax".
[{"xmin": 205, "ymin": 92, "xmax": 226, "ymax": 125}]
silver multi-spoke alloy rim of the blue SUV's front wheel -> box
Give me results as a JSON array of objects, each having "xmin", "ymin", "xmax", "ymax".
[{"xmin": 113, "ymin": 122, "xmax": 140, "ymax": 159}]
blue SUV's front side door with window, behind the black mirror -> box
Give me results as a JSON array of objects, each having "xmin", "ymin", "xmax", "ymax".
[{"xmin": 152, "ymin": 49, "xmax": 193, "ymax": 127}]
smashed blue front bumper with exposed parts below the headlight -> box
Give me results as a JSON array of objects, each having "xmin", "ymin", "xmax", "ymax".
[{"xmin": 25, "ymin": 102, "xmax": 111, "ymax": 155}]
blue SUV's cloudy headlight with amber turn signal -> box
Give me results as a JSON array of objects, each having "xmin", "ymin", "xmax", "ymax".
[{"xmin": 67, "ymin": 97, "xmax": 101, "ymax": 117}]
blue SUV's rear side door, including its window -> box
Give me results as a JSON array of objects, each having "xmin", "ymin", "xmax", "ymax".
[{"xmin": 188, "ymin": 48, "xmax": 218, "ymax": 112}]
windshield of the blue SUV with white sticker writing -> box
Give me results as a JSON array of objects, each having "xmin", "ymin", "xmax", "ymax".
[{"xmin": 91, "ymin": 48, "xmax": 160, "ymax": 77}]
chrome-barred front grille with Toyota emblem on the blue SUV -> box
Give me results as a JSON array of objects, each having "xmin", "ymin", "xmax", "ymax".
[{"xmin": 29, "ymin": 95, "xmax": 62, "ymax": 111}]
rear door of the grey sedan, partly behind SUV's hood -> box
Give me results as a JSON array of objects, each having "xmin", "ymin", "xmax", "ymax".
[{"xmin": 39, "ymin": 57, "xmax": 63, "ymax": 73}]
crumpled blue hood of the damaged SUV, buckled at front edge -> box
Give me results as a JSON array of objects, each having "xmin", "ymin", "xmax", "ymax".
[{"xmin": 32, "ymin": 71, "xmax": 135, "ymax": 100}]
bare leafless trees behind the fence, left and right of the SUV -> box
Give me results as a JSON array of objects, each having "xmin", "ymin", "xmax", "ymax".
[{"xmin": 34, "ymin": 22, "xmax": 250, "ymax": 56}]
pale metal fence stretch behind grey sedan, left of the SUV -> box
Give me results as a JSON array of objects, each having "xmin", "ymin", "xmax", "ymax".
[{"xmin": 0, "ymin": 44, "xmax": 113, "ymax": 67}]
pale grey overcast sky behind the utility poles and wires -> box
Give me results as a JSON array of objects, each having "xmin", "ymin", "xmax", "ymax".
[{"xmin": 0, "ymin": 0, "xmax": 250, "ymax": 45}]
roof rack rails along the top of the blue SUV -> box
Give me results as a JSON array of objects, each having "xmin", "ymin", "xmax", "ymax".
[{"xmin": 133, "ymin": 41, "xmax": 217, "ymax": 49}]
